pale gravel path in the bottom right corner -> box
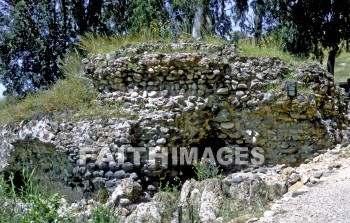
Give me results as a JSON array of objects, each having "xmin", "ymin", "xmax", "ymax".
[{"xmin": 258, "ymin": 167, "xmax": 350, "ymax": 223}]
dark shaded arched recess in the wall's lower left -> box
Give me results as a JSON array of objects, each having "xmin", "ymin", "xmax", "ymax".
[{"xmin": 0, "ymin": 140, "xmax": 82, "ymax": 201}]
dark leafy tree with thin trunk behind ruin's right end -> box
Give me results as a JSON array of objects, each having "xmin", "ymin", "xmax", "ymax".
[{"xmin": 273, "ymin": 0, "xmax": 350, "ymax": 74}]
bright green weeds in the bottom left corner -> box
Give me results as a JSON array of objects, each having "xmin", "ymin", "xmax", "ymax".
[{"xmin": 0, "ymin": 168, "xmax": 120, "ymax": 223}]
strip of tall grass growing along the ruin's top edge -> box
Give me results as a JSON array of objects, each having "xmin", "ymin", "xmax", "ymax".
[{"xmin": 76, "ymin": 33, "xmax": 303, "ymax": 62}]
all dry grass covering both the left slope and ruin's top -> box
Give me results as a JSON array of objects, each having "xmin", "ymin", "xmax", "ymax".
[{"xmin": 0, "ymin": 33, "xmax": 318, "ymax": 124}]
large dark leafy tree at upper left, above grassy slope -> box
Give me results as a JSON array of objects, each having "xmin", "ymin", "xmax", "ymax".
[{"xmin": 0, "ymin": 0, "xmax": 136, "ymax": 97}]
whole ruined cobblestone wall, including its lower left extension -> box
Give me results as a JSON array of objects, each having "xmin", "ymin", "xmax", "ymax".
[{"xmin": 0, "ymin": 43, "xmax": 349, "ymax": 199}]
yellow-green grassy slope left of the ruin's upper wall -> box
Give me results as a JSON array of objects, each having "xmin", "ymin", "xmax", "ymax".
[{"xmin": 0, "ymin": 52, "xmax": 136, "ymax": 124}]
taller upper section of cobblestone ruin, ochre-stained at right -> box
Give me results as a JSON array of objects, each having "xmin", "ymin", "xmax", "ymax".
[{"xmin": 84, "ymin": 44, "xmax": 348, "ymax": 163}]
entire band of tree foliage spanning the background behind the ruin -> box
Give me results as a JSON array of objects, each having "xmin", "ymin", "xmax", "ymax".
[{"xmin": 0, "ymin": 0, "xmax": 350, "ymax": 98}]
